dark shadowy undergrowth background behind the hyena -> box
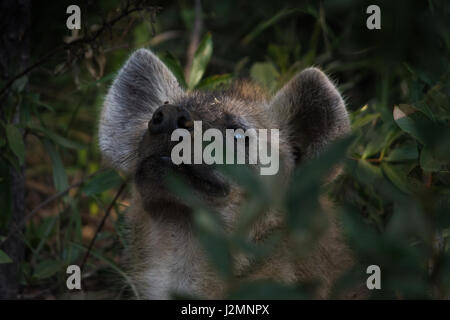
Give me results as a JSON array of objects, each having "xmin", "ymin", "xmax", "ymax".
[{"xmin": 0, "ymin": 0, "xmax": 450, "ymax": 299}]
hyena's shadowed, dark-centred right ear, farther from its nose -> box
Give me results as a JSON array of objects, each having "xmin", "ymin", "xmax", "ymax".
[{"xmin": 269, "ymin": 68, "xmax": 350, "ymax": 163}]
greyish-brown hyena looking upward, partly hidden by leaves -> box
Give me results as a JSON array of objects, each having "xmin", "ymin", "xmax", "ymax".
[{"xmin": 99, "ymin": 49, "xmax": 362, "ymax": 299}]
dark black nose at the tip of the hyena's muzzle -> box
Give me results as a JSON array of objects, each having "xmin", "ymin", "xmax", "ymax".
[{"xmin": 148, "ymin": 104, "xmax": 194, "ymax": 134}]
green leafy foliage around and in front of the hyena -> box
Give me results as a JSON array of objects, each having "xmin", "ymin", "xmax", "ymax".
[{"xmin": 0, "ymin": 0, "xmax": 450, "ymax": 299}]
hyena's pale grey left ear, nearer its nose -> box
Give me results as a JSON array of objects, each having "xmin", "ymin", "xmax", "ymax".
[{"xmin": 99, "ymin": 49, "xmax": 183, "ymax": 172}]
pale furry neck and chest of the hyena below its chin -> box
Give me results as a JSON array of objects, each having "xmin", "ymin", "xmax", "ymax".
[{"xmin": 127, "ymin": 192, "xmax": 222, "ymax": 299}]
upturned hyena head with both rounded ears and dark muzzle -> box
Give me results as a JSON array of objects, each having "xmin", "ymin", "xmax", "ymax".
[{"xmin": 99, "ymin": 49, "xmax": 349, "ymax": 215}]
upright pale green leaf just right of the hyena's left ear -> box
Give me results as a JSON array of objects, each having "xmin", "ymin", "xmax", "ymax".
[{"xmin": 188, "ymin": 32, "xmax": 213, "ymax": 89}]
